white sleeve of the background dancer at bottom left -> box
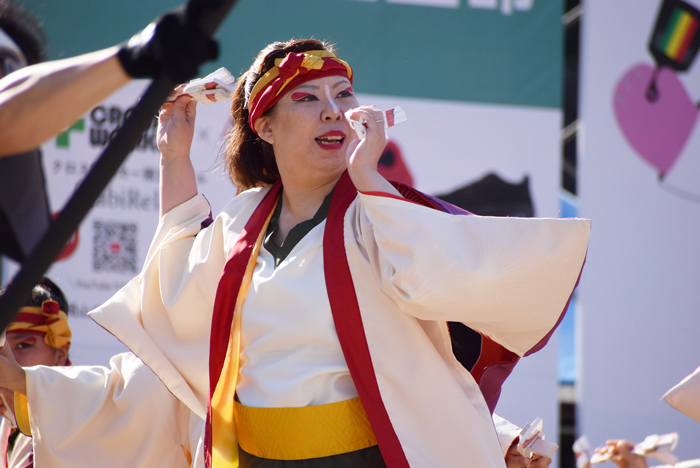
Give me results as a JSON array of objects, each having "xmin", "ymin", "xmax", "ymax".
[{"xmin": 27, "ymin": 353, "xmax": 195, "ymax": 468}]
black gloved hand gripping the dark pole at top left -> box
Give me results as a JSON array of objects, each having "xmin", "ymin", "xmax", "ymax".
[{"xmin": 117, "ymin": 9, "xmax": 219, "ymax": 83}]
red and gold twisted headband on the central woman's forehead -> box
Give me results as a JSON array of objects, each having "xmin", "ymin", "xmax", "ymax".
[{"xmin": 246, "ymin": 50, "xmax": 352, "ymax": 134}]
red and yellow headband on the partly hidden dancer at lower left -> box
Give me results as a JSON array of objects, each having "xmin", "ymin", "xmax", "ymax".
[{"xmin": 7, "ymin": 300, "xmax": 73, "ymax": 348}]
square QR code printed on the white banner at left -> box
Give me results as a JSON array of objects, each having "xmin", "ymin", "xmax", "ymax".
[{"xmin": 92, "ymin": 221, "xmax": 138, "ymax": 273}]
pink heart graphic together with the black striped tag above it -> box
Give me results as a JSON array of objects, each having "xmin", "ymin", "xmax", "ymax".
[{"xmin": 613, "ymin": 0, "xmax": 700, "ymax": 202}]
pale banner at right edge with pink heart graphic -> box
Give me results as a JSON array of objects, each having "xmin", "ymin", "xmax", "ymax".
[{"xmin": 579, "ymin": 0, "xmax": 700, "ymax": 460}]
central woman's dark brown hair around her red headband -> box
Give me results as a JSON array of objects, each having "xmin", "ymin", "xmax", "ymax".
[{"xmin": 225, "ymin": 39, "xmax": 333, "ymax": 192}]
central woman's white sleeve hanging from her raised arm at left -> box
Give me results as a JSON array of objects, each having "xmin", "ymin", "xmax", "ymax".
[{"xmin": 90, "ymin": 195, "xmax": 226, "ymax": 417}]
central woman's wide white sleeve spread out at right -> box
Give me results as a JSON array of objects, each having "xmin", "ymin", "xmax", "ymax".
[{"xmin": 355, "ymin": 190, "xmax": 590, "ymax": 356}]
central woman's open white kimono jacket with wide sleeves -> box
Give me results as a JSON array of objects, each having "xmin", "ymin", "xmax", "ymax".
[{"xmin": 20, "ymin": 174, "xmax": 590, "ymax": 468}]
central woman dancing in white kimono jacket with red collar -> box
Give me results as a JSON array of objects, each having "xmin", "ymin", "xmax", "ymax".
[{"xmin": 1, "ymin": 40, "xmax": 589, "ymax": 467}]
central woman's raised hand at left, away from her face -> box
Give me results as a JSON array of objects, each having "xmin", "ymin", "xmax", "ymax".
[{"xmin": 156, "ymin": 85, "xmax": 197, "ymax": 161}]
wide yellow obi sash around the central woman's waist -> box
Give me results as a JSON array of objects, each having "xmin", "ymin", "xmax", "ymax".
[{"xmin": 234, "ymin": 398, "xmax": 377, "ymax": 460}]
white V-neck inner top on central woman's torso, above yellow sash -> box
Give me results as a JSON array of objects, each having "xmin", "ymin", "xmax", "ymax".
[{"xmin": 236, "ymin": 221, "xmax": 357, "ymax": 408}]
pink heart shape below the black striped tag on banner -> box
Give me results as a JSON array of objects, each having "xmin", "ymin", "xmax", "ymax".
[{"xmin": 613, "ymin": 64, "xmax": 698, "ymax": 176}]
